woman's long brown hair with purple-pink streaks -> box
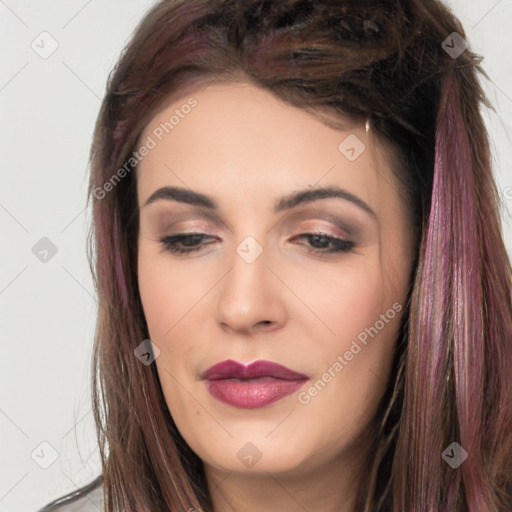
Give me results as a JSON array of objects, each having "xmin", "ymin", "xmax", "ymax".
[{"xmin": 41, "ymin": 0, "xmax": 512, "ymax": 512}]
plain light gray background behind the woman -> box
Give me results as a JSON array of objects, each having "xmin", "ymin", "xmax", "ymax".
[{"xmin": 0, "ymin": 0, "xmax": 512, "ymax": 512}]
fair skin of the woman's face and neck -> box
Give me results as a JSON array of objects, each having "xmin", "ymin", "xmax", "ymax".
[{"xmin": 137, "ymin": 83, "xmax": 413, "ymax": 512}]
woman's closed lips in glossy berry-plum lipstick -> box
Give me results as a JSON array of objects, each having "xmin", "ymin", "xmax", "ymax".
[{"xmin": 201, "ymin": 359, "xmax": 309, "ymax": 409}]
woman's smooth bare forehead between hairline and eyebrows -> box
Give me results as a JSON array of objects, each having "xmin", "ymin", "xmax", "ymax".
[{"xmin": 137, "ymin": 83, "xmax": 400, "ymax": 212}]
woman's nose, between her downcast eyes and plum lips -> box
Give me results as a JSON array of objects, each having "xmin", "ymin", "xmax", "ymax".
[{"xmin": 216, "ymin": 241, "xmax": 287, "ymax": 335}]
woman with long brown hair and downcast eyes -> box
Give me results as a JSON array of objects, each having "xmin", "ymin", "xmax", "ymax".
[{"xmin": 37, "ymin": 0, "xmax": 512, "ymax": 512}]
